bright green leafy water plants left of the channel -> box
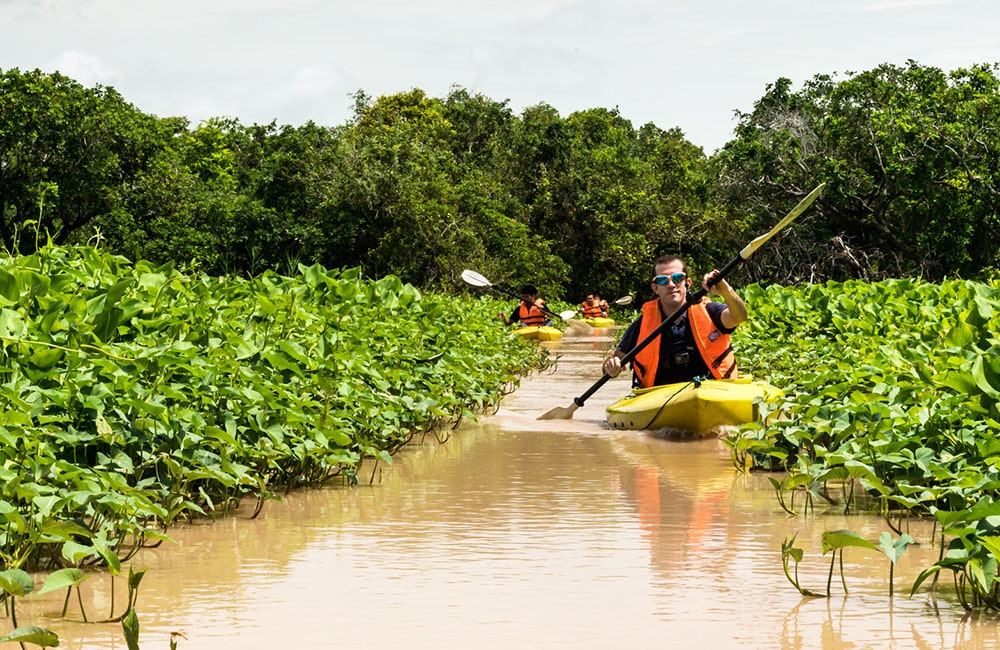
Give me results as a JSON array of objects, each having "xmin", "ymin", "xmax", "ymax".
[{"xmin": 0, "ymin": 246, "xmax": 547, "ymax": 568}]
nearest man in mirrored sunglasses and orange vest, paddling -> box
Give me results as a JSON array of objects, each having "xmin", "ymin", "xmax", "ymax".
[{"xmin": 604, "ymin": 255, "xmax": 748, "ymax": 388}]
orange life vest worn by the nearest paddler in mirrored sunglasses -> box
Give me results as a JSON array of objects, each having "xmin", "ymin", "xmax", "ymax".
[{"xmin": 632, "ymin": 298, "xmax": 739, "ymax": 388}]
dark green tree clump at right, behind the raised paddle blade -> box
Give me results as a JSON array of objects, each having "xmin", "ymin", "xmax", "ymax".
[{"xmin": 715, "ymin": 61, "xmax": 1000, "ymax": 281}]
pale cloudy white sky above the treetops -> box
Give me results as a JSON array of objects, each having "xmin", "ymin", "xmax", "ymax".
[{"xmin": 0, "ymin": 0, "xmax": 1000, "ymax": 154}]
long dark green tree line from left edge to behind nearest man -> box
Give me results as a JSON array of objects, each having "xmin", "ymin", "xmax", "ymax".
[{"xmin": 0, "ymin": 70, "xmax": 720, "ymax": 302}]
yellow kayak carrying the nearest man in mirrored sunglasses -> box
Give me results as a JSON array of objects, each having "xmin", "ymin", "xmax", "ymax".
[{"xmin": 607, "ymin": 377, "xmax": 781, "ymax": 434}]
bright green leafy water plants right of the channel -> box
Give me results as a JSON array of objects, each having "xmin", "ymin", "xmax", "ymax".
[{"xmin": 728, "ymin": 280, "xmax": 1000, "ymax": 608}]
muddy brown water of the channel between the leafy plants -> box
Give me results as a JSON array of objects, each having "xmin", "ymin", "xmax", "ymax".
[{"xmin": 13, "ymin": 331, "xmax": 1000, "ymax": 650}]
